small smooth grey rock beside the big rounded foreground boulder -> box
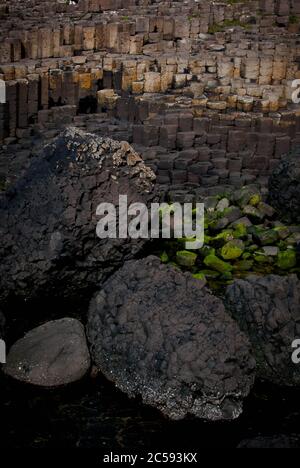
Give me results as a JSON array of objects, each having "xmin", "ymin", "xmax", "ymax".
[{"xmin": 3, "ymin": 318, "xmax": 90, "ymax": 387}]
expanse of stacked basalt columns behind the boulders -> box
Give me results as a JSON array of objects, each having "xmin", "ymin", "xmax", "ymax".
[{"xmin": 0, "ymin": 0, "xmax": 300, "ymax": 193}]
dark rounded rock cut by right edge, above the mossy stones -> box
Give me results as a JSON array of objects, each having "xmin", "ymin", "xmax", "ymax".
[{"xmin": 269, "ymin": 147, "xmax": 300, "ymax": 223}]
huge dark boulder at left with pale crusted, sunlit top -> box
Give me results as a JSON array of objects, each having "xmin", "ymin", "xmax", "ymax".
[{"xmin": 0, "ymin": 128, "xmax": 155, "ymax": 299}]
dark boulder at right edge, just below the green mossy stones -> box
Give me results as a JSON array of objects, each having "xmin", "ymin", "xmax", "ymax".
[{"xmin": 226, "ymin": 275, "xmax": 300, "ymax": 385}]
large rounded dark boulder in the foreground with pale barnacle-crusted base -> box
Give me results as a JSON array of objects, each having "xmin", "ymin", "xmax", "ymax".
[{"xmin": 87, "ymin": 257, "xmax": 255, "ymax": 421}]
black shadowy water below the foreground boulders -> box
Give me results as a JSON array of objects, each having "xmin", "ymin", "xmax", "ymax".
[{"xmin": 0, "ymin": 376, "xmax": 300, "ymax": 453}]
